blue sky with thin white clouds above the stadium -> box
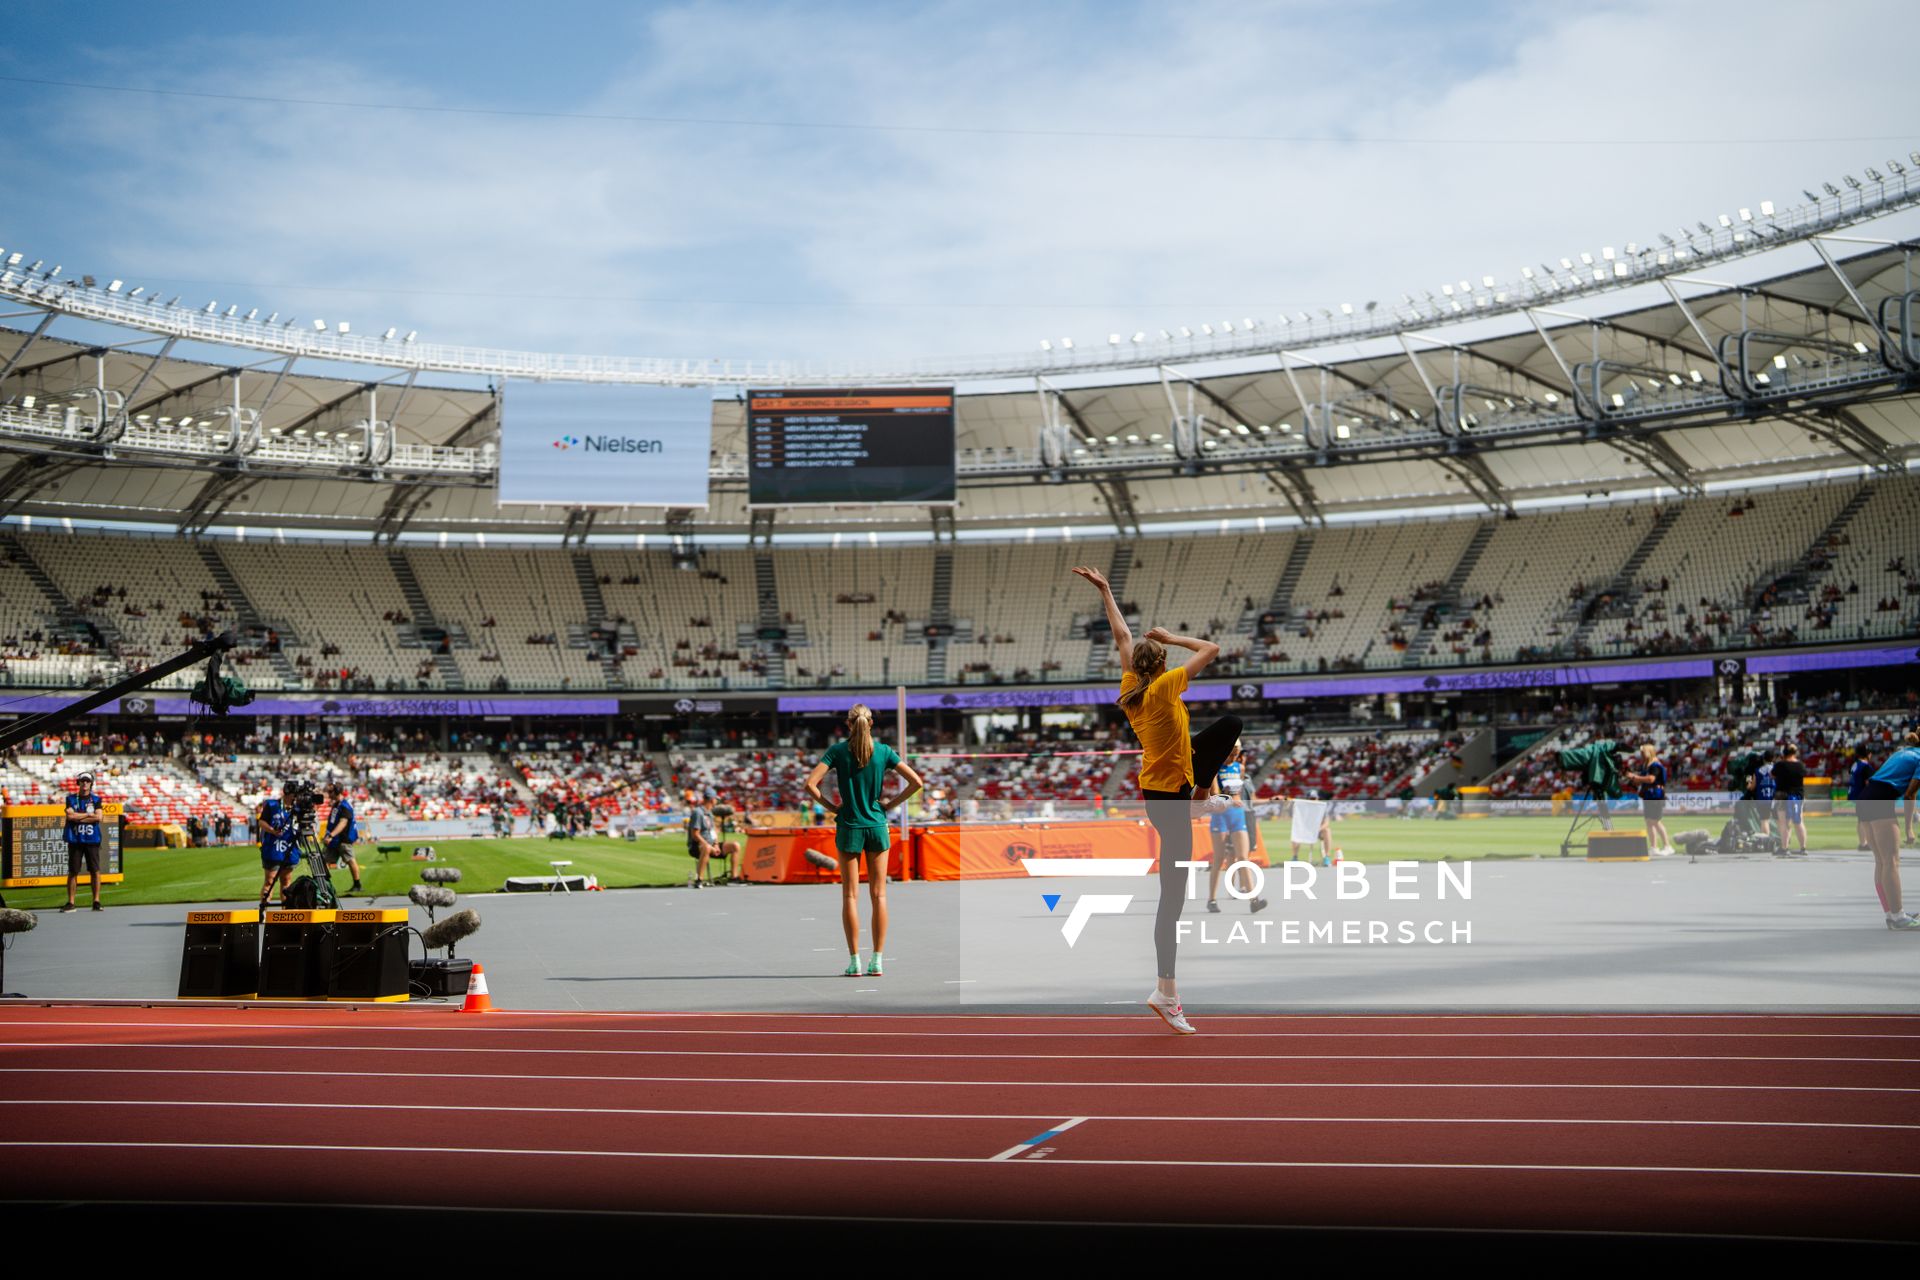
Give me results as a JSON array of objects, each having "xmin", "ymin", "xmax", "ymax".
[{"xmin": 0, "ymin": 0, "xmax": 1920, "ymax": 368}]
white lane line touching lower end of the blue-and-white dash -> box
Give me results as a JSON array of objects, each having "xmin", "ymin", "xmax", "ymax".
[{"xmin": 0, "ymin": 1138, "xmax": 1920, "ymax": 1180}]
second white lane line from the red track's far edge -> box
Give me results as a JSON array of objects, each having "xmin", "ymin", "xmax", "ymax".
[{"xmin": 0, "ymin": 1036, "xmax": 1920, "ymax": 1065}]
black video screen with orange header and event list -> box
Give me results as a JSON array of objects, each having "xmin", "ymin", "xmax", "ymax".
[{"xmin": 747, "ymin": 388, "xmax": 954, "ymax": 507}]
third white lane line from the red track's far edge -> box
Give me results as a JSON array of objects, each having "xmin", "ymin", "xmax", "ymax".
[{"xmin": 0, "ymin": 1067, "xmax": 1920, "ymax": 1094}]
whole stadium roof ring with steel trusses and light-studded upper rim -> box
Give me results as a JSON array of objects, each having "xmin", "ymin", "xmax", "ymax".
[{"xmin": 0, "ymin": 171, "xmax": 1920, "ymax": 541}]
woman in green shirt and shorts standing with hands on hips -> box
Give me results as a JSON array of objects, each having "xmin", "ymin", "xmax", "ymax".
[{"xmin": 806, "ymin": 702, "xmax": 922, "ymax": 979}]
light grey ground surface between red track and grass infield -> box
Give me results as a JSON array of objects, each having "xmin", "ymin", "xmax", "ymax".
[{"xmin": 6, "ymin": 854, "xmax": 1920, "ymax": 1017}]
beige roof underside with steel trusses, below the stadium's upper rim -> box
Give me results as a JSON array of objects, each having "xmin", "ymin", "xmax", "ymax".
[{"xmin": 0, "ymin": 206, "xmax": 1920, "ymax": 535}]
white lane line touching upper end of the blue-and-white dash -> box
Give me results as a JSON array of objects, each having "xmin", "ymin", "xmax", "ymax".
[{"xmin": 0, "ymin": 1098, "xmax": 1920, "ymax": 1128}]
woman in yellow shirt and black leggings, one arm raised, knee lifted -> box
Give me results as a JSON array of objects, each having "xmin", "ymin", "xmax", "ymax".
[{"xmin": 1073, "ymin": 566, "xmax": 1240, "ymax": 1036}]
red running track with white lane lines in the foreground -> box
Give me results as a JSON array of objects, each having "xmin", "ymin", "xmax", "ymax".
[{"xmin": 0, "ymin": 1006, "xmax": 1920, "ymax": 1240}]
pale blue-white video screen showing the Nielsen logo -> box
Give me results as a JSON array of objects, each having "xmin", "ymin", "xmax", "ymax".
[{"xmin": 499, "ymin": 382, "xmax": 714, "ymax": 507}]
